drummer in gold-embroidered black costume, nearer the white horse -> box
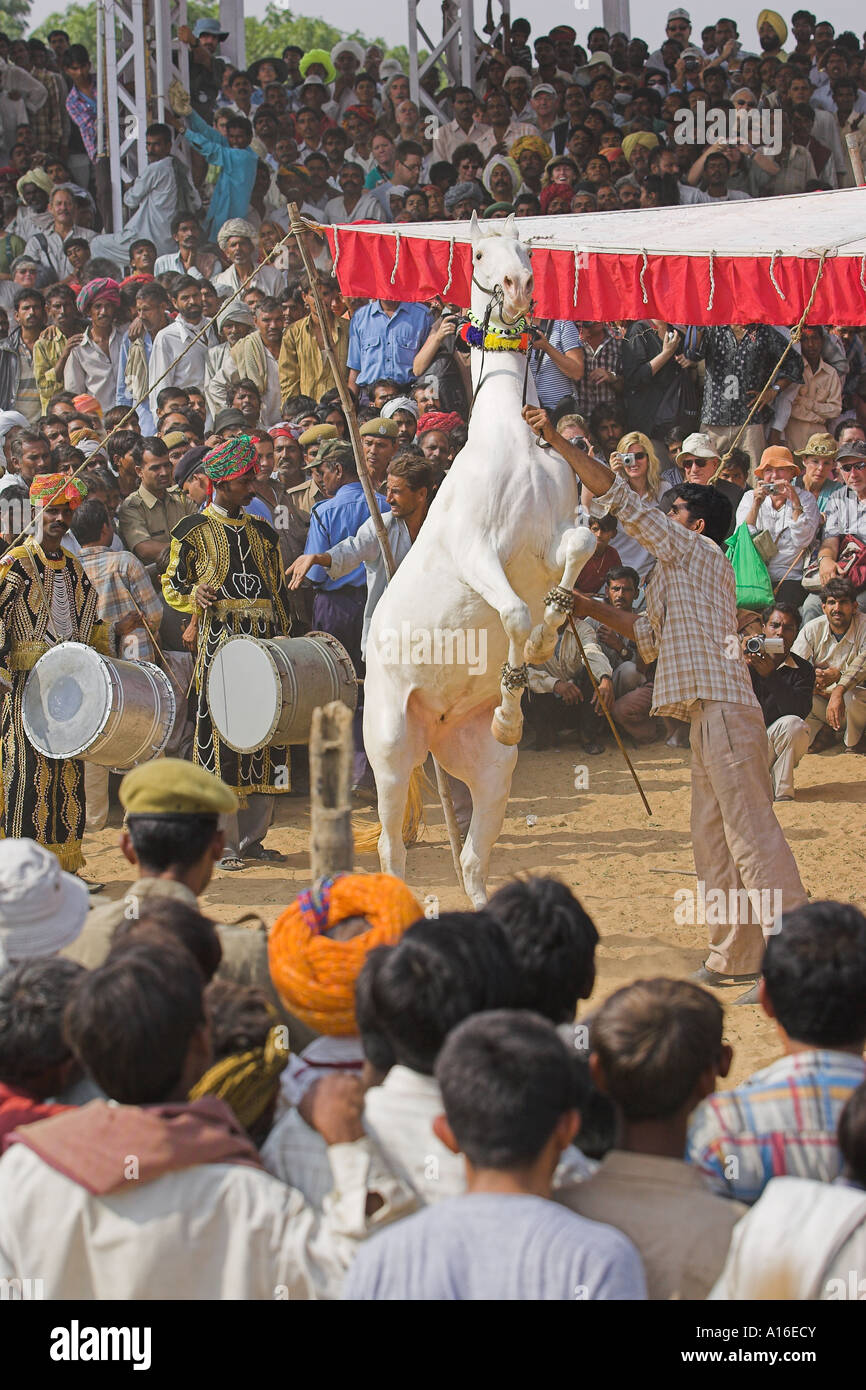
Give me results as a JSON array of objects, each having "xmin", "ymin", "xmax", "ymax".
[{"xmin": 163, "ymin": 435, "xmax": 291, "ymax": 869}]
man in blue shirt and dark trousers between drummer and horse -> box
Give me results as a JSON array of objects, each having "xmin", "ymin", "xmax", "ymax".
[{"xmin": 304, "ymin": 439, "xmax": 389, "ymax": 794}]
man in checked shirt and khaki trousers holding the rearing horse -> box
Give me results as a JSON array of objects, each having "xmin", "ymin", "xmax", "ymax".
[{"xmin": 523, "ymin": 406, "xmax": 806, "ymax": 1004}]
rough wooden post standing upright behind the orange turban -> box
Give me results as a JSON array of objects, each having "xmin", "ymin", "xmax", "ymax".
[{"xmin": 310, "ymin": 701, "xmax": 354, "ymax": 884}]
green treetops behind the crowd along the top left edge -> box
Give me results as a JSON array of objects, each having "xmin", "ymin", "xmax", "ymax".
[{"xmin": 33, "ymin": 0, "xmax": 409, "ymax": 71}]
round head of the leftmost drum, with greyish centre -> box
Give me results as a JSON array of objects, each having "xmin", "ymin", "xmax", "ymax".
[{"xmin": 22, "ymin": 642, "xmax": 111, "ymax": 758}]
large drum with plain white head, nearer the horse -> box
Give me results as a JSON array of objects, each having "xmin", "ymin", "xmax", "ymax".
[{"xmin": 207, "ymin": 632, "xmax": 357, "ymax": 753}]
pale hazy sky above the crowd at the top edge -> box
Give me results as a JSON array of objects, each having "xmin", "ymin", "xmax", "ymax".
[{"xmin": 31, "ymin": 0, "xmax": 866, "ymax": 47}]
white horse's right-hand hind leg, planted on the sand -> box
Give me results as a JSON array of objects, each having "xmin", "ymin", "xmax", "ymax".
[{"xmin": 436, "ymin": 710, "xmax": 517, "ymax": 908}]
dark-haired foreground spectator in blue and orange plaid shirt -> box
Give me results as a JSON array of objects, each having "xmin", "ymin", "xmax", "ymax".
[{"xmin": 688, "ymin": 902, "xmax": 866, "ymax": 1204}]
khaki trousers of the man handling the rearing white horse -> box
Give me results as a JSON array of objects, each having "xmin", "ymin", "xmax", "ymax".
[{"xmin": 691, "ymin": 701, "xmax": 806, "ymax": 974}]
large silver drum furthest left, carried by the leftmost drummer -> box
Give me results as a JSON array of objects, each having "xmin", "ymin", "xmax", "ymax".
[{"xmin": 22, "ymin": 642, "xmax": 175, "ymax": 771}]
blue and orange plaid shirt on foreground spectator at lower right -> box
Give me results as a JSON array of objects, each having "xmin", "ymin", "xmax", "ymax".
[{"xmin": 687, "ymin": 1051, "xmax": 866, "ymax": 1202}]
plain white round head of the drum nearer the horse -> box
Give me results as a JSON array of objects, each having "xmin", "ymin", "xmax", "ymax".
[{"xmin": 207, "ymin": 637, "xmax": 282, "ymax": 753}]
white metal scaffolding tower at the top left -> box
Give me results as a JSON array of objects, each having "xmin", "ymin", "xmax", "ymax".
[{"xmin": 96, "ymin": 0, "xmax": 189, "ymax": 231}]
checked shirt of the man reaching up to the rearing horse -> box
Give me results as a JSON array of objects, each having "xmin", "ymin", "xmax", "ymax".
[{"xmin": 589, "ymin": 477, "xmax": 758, "ymax": 720}]
